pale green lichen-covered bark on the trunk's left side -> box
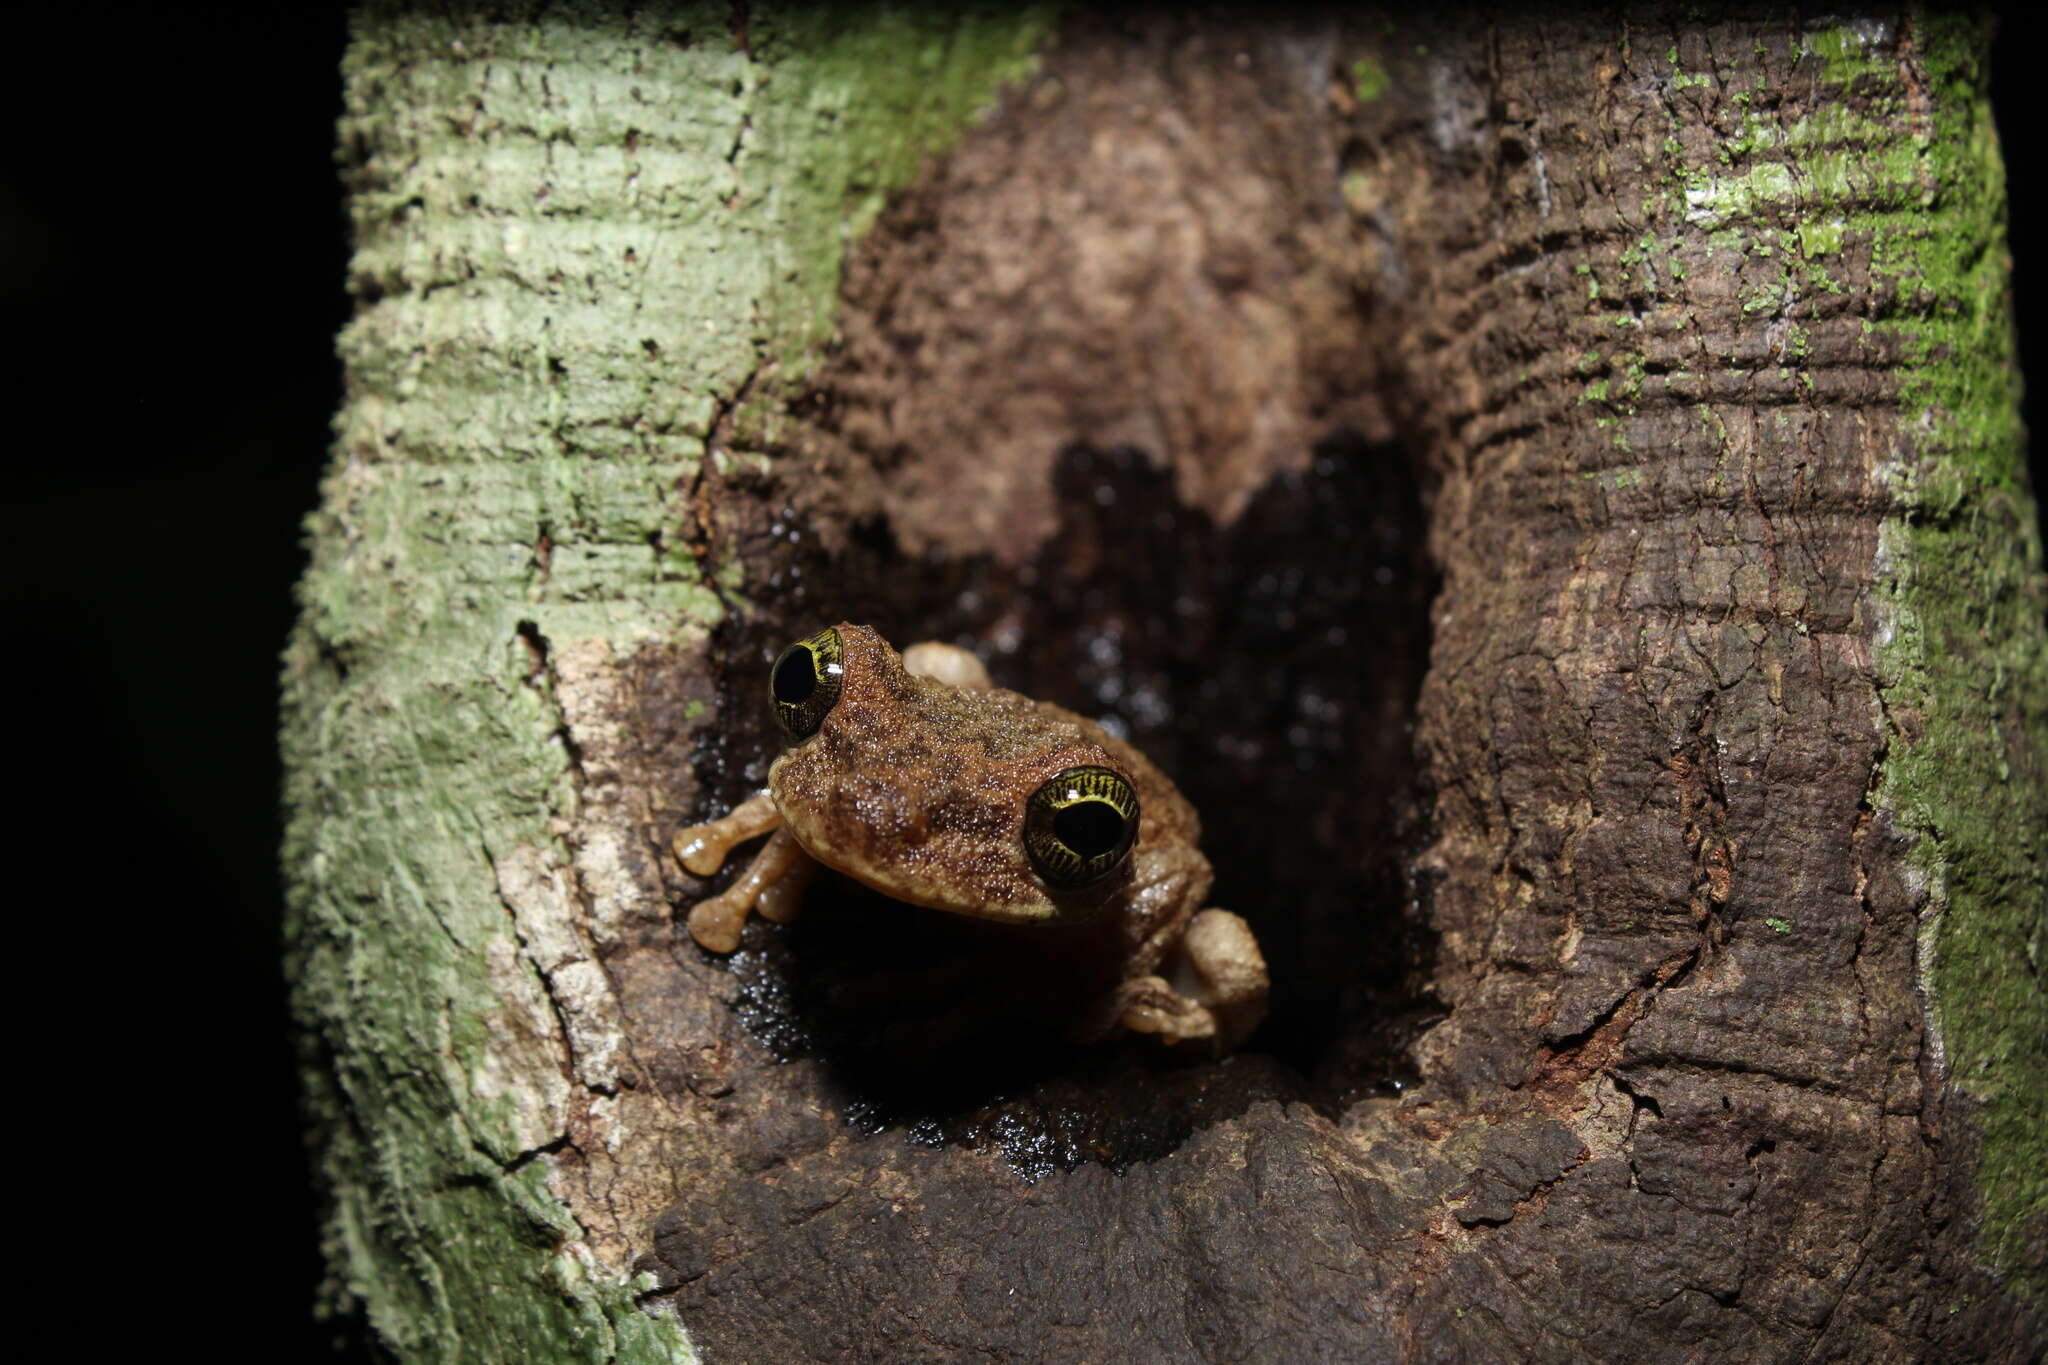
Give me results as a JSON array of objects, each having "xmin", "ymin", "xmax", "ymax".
[{"xmin": 285, "ymin": 4, "xmax": 1044, "ymax": 1361}]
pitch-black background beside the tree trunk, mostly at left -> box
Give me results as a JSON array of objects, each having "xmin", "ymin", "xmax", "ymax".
[{"xmin": 12, "ymin": 6, "xmax": 2048, "ymax": 1359}]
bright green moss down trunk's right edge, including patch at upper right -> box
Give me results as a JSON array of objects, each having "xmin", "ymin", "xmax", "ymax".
[{"xmin": 1622, "ymin": 5, "xmax": 2048, "ymax": 1302}]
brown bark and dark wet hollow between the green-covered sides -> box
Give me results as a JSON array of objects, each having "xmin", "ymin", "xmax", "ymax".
[{"xmin": 610, "ymin": 18, "xmax": 2044, "ymax": 1361}]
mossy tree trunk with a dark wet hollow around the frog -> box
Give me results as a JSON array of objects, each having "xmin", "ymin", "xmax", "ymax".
[{"xmin": 285, "ymin": 6, "xmax": 2048, "ymax": 1361}]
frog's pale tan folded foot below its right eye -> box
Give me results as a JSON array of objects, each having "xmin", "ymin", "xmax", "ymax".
[{"xmin": 1116, "ymin": 911, "xmax": 1268, "ymax": 1048}]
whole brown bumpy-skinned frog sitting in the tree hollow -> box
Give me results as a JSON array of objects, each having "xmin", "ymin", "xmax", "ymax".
[{"xmin": 674, "ymin": 622, "xmax": 1270, "ymax": 1052}]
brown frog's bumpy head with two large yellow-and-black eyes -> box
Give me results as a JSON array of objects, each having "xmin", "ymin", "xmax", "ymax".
[{"xmin": 768, "ymin": 624, "xmax": 1139, "ymax": 923}]
